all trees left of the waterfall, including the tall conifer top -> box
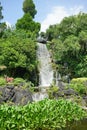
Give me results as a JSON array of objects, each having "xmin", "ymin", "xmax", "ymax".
[{"xmin": 0, "ymin": 0, "xmax": 40, "ymax": 85}]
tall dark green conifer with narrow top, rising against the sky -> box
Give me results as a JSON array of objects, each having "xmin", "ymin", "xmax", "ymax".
[{"xmin": 16, "ymin": 0, "xmax": 40, "ymax": 35}]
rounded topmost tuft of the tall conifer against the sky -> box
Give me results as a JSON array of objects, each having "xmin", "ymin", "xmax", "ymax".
[{"xmin": 23, "ymin": 0, "xmax": 37, "ymax": 18}]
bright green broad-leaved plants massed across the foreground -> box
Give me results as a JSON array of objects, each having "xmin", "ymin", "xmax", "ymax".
[{"xmin": 0, "ymin": 99, "xmax": 87, "ymax": 130}]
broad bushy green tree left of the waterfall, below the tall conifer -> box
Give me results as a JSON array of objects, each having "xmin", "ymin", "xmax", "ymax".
[{"xmin": 0, "ymin": 30, "xmax": 37, "ymax": 82}]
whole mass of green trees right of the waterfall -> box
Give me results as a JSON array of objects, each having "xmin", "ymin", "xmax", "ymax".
[{"xmin": 45, "ymin": 13, "xmax": 87, "ymax": 78}]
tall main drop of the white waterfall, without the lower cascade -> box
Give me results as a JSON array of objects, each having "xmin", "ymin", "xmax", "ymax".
[{"xmin": 37, "ymin": 43, "xmax": 53, "ymax": 87}]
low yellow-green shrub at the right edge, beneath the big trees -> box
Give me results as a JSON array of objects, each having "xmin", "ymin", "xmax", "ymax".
[{"xmin": 69, "ymin": 78, "xmax": 87, "ymax": 95}]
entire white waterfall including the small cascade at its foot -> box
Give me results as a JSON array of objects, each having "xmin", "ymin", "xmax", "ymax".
[{"xmin": 33, "ymin": 43, "xmax": 53, "ymax": 101}]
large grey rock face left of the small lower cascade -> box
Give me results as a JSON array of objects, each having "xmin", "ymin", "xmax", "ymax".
[{"xmin": 0, "ymin": 85, "xmax": 33, "ymax": 105}]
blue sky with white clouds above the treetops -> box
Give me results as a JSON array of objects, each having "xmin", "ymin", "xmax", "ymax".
[{"xmin": 0, "ymin": 0, "xmax": 87, "ymax": 32}]
